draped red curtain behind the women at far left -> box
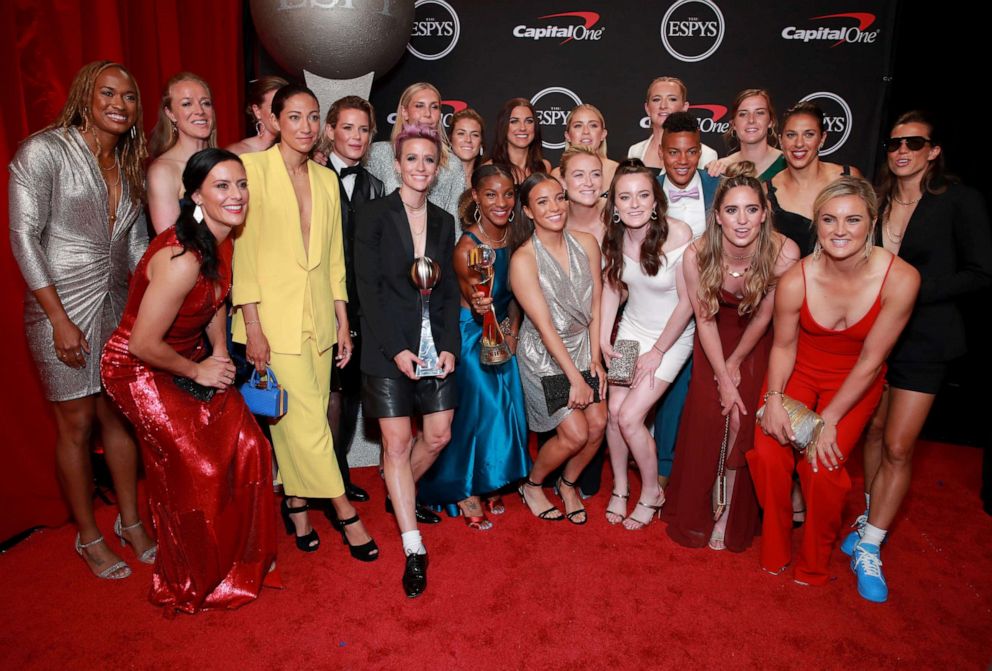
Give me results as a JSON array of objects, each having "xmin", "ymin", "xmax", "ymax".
[{"xmin": 0, "ymin": 0, "xmax": 244, "ymax": 541}]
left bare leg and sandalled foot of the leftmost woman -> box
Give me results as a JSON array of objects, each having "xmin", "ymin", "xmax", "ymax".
[{"xmin": 52, "ymin": 395, "xmax": 125, "ymax": 577}]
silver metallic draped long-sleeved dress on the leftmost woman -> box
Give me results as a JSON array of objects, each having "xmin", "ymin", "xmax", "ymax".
[{"xmin": 9, "ymin": 128, "xmax": 148, "ymax": 401}]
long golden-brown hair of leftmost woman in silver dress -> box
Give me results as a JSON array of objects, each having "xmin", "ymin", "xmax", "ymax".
[{"xmin": 38, "ymin": 61, "xmax": 148, "ymax": 203}]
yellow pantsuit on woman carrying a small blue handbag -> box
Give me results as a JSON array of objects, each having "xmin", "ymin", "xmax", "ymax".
[{"xmin": 231, "ymin": 144, "xmax": 348, "ymax": 498}]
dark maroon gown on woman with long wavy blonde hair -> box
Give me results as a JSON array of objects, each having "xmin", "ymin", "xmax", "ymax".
[{"xmin": 662, "ymin": 289, "xmax": 772, "ymax": 552}]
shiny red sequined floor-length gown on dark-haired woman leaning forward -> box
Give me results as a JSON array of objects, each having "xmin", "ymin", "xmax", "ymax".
[{"xmin": 101, "ymin": 228, "xmax": 276, "ymax": 613}]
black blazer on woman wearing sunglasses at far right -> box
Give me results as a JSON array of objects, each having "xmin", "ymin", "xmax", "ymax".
[{"xmin": 875, "ymin": 184, "xmax": 992, "ymax": 363}]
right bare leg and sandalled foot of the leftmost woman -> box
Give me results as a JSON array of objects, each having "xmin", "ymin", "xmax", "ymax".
[{"xmin": 96, "ymin": 394, "xmax": 155, "ymax": 557}]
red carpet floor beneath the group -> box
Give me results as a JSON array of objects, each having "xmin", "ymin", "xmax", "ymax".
[{"xmin": 0, "ymin": 444, "xmax": 992, "ymax": 670}]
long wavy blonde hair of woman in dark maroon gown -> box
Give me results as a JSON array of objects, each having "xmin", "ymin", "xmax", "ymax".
[{"xmin": 696, "ymin": 161, "xmax": 782, "ymax": 317}]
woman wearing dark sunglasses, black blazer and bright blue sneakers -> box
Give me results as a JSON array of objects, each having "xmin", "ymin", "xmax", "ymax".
[{"xmin": 841, "ymin": 111, "xmax": 992, "ymax": 602}]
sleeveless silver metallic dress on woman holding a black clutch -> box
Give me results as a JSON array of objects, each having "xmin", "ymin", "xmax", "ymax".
[{"xmin": 517, "ymin": 232, "xmax": 592, "ymax": 432}]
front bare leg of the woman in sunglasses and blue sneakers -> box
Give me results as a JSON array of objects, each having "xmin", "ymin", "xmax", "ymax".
[{"xmin": 868, "ymin": 389, "xmax": 936, "ymax": 529}]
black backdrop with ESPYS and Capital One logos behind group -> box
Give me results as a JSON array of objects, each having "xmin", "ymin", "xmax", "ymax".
[{"xmin": 248, "ymin": 0, "xmax": 896, "ymax": 174}]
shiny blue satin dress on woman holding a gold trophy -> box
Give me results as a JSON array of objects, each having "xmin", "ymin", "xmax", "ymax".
[{"xmin": 418, "ymin": 233, "xmax": 531, "ymax": 515}]
